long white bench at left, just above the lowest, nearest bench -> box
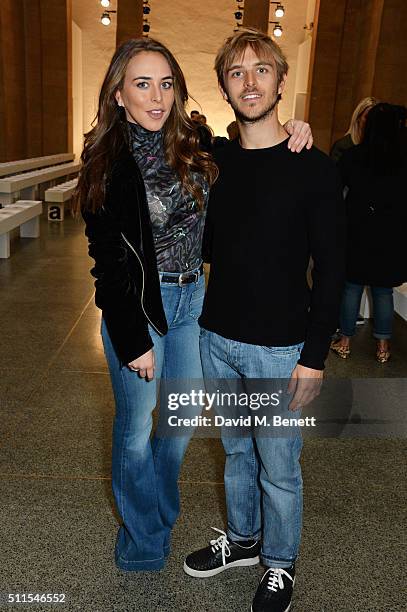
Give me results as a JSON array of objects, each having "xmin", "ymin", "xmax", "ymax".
[{"xmin": 0, "ymin": 162, "xmax": 81, "ymax": 205}]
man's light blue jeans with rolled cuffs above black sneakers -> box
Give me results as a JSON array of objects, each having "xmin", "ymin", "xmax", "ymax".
[{"xmin": 200, "ymin": 329, "xmax": 302, "ymax": 568}]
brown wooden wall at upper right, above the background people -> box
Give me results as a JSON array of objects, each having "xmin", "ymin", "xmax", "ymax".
[{"xmin": 308, "ymin": 0, "xmax": 407, "ymax": 151}]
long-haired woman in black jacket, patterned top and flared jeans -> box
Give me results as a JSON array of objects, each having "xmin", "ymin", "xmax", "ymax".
[{"xmin": 77, "ymin": 38, "xmax": 308, "ymax": 571}]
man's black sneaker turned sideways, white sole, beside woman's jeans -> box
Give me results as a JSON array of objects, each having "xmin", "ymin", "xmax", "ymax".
[{"xmin": 184, "ymin": 527, "xmax": 260, "ymax": 578}]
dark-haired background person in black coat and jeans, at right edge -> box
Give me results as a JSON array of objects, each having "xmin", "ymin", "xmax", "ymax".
[{"xmin": 331, "ymin": 103, "xmax": 407, "ymax": 363}]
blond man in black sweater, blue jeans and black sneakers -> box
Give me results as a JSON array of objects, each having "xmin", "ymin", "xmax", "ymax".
[{"xmin": 184, "ymin": 30, "xmax": 344, "ymax": 612}]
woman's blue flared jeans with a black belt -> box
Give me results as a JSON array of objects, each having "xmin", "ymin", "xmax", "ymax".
[{"xmin": 102, "ymin": 276, "xmax": 205, "ymax": 571}]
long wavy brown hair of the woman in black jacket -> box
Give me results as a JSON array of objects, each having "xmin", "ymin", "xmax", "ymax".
[{"xmin": 74, "ymin": 38, "xmax": 217, "ymax": 213}]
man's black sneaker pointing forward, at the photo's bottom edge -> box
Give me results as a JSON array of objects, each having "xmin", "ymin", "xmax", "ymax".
[{"xmin": 252, "ymin": 565, "xmax": 295, "ymax": 612}]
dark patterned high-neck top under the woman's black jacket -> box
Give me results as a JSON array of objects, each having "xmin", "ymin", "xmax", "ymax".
[{"xmin": 128, "ymin": 122, "xmax": 209, "ymax": 272}]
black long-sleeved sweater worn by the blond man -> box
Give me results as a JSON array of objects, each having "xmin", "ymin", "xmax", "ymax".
[{"xmin": 199, "ymin": 140, "xmax": 345, "ymax": 370}]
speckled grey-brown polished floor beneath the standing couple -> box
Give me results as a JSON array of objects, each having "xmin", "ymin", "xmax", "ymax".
[{"xmin": 0, "ymin": 219, "xmax": 407, "ymax": 612}]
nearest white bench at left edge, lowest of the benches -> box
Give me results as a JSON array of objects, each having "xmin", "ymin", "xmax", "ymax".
[{"xmin": 0, "ymin": 200, "xmax": 42, "ymax": 259}]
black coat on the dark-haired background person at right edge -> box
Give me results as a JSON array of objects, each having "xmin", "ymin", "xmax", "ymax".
[{"xmin": 338, "ymin": 145, "xmax": 407, "ymax": 287}]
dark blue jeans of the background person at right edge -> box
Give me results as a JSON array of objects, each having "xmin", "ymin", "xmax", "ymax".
[{"xmin": 339, "ymin": 282, "xmax": 394, "ymax": 340}]
